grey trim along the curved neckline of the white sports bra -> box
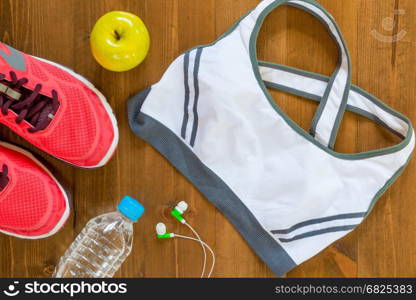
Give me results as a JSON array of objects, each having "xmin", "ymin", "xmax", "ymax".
[{"xmin": 250, "ymin": 0, "xmax": 413, "ymax": 160}]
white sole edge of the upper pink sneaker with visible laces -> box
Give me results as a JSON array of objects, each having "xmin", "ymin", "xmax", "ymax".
[{"xmin": 32, "ymin": 56, "xmax": 119, "ymax": 169}]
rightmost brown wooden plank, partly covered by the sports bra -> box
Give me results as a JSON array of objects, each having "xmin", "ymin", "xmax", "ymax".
[{"xmin": 357, "ymin": 1, "xmax": 416, "ymax": 277}]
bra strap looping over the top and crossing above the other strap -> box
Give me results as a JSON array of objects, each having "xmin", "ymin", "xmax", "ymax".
[{"xmin": 252, "ymin": 0, "xmax": 351, "ymax": 148}]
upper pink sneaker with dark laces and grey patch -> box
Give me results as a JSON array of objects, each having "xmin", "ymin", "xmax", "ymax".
[{"xmin": 0, "ymin": 43, "xmax": 118, "ymax": 168}]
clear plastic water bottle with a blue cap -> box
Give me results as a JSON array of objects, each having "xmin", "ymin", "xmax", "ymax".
[{"xmin": 53, "ymin": 196, "xmax": 144, "ymax": 278}]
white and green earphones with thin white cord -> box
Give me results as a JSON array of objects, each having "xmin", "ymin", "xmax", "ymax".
[{"xmin": 156, "ymin": 201, "xmax": 215, "ymax": 278}]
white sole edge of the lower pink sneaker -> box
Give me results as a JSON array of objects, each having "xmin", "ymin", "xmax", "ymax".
[{"xmin": 0, "ymin": 142, "xmax": 71, "ymax": 240}]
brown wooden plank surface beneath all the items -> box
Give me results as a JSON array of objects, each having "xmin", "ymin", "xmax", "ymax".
[{"xmin": 0, "ymin": 0, "xmax": 416, "ymax": 277}]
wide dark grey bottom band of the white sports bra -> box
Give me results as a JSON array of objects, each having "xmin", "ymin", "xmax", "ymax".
[{"xmin": 128, "ymin": 88, "xmax": 296, "ymax": 276}]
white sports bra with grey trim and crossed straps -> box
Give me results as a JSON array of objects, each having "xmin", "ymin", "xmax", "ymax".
[{"xmin": 129, "ymin": 0, "xmax": 415, "ymax": 275}]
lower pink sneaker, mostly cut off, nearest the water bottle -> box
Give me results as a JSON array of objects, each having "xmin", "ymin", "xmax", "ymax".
[{"xmin": 0, "ymin": 143, "xmax": 70, "ymax": 239}]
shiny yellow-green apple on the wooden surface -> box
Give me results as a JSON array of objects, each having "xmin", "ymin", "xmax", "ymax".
[{"xmin": 90, "ymin": 11, "xmax": 150, "ymax": 72}]
